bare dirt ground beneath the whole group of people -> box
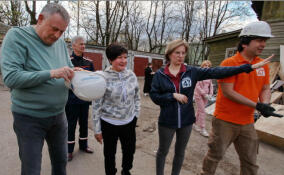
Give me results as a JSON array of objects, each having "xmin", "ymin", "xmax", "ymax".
[{"xmin": 0, "ymin": 79, "xmax": 284, "ymax": 175}]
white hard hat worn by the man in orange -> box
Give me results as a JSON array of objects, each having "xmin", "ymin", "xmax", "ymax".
[{"xmin": 239, "ymin": 21, "xmax": 274, "ymax": 38}]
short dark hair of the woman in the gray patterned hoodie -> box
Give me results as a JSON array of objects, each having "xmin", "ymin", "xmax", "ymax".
[{"xmin": 106, "ymin": 43, "xmax": 128, "ymax": 61}]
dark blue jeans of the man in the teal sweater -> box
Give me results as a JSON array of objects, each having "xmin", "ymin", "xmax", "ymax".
[{"xmin": 13, "ymin": 112, "xmax": 68, "ymax": 175}]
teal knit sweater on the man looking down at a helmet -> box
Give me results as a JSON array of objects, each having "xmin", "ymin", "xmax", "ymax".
[{"xmin": 1, "ymin": 26, "xmax": 73, "ymax": 118}]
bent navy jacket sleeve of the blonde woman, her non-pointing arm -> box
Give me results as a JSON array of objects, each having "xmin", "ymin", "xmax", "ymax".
[{"xmin": 150, "ymin": 73, "xmax": 176, "ymax": 106}]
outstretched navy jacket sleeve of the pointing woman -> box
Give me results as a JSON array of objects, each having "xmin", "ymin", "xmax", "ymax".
[{"xmin": 196, "ymin": 64, "xmax": 253, "ymax": 81}]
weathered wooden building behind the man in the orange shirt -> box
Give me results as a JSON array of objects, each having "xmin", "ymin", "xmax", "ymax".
[{"xmin": 204, "ymin": 1, "xmax": 284, "ymax": 66}]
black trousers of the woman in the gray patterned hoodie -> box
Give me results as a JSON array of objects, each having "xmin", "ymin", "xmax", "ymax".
[{"xmin": 101, "ymin": 117, "xmax": 137, "ymax": 175}]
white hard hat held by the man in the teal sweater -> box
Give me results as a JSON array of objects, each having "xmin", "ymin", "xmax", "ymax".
[{"xmin": 65, "ymin": 71, "xmax": 106, "ymax": 101}]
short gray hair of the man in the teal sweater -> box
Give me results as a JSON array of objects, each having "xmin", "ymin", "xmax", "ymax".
[{"xmin": 40, "ymin": 3, "xmax": 70, "ymax": 23}]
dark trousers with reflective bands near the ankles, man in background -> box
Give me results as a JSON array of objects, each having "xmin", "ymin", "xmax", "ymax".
[{"xmin": 65, "ymin": 104, "xmax": 89, "ymax": 153}]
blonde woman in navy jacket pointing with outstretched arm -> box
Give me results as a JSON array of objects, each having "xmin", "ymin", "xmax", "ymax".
[{"xmin": 150, "ymin": 40, "xmax": 271, "ymax": 175}]
